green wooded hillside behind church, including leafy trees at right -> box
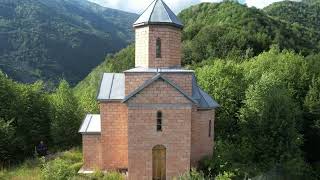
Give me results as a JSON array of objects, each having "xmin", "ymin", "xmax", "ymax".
[{"xmin": 75, "ymin": 2, "xmax": 320, "ymax": 179}]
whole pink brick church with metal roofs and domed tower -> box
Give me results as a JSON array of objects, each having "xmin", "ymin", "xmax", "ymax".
[{"xmin": 79, "ymin": 0, "xmax": 219, "ymax": 180}]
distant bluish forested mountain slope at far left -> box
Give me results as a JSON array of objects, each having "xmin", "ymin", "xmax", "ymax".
[{"xmin": 0, "ymin": 0, "xmax": 137, "ymax": 86}]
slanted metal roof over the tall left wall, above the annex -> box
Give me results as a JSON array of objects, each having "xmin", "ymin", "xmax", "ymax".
[{"xmin": 97, "ymin": 73, "xmax": 125, "ymax": 101}]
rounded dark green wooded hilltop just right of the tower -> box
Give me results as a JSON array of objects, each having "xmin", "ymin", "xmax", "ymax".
[{"xmin": 179, "ymin": 2, "xmax": 320, "ymax": 63}]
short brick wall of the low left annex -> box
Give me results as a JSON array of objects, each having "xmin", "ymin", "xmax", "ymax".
[{"xmin": 82, "ymin": 134, "xmax": 101, "ymax": 170}]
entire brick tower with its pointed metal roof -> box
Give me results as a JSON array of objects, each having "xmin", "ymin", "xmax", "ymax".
[{"xmin": 133, "ymin": 0, "xmax": 183, "ymax": 68}]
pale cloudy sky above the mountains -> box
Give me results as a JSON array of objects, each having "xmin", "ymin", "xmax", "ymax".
[{"xmin": 89, "ymin": 0, "xmax": 298, "ymax": 14}]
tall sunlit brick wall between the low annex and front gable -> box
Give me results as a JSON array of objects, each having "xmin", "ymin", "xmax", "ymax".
[{"xmin": 100, "ymin": 102, "xmax": 128, "ymax": 170}]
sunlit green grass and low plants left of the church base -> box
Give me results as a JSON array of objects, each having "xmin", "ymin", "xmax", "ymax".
[{"xmin": 0, "ymin": 148, "xmax": 124, "ymax": 180}]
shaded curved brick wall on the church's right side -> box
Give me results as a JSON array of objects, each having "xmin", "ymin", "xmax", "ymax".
[{"xmin": 191, "ymin": 108, "xmax": 214, "ymax": 167}]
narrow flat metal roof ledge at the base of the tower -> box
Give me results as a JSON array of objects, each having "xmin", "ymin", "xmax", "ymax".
[{"xmin": 124, "ymin": 67, "xmax": 194, "ymax": 73}]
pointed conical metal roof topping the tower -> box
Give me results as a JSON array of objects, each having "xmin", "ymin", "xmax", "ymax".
[{"xmin": 133, "ymin": 0, "xmax": 183, "ymax": 28}]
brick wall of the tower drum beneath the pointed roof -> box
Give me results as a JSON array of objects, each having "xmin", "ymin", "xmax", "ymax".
[{"xmin": 135, "ymin": 25, "xmax": 181, "ymax": 68}]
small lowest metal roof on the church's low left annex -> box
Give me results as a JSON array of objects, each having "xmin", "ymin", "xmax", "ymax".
[{"xmin": 79, "ymin": 114, "xmax": 101, "ymax": 134}]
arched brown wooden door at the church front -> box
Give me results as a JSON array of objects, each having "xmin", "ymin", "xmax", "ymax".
[{"xmin": 152, "ymin": 145, "xmax": 166, "ymax": 180}]
